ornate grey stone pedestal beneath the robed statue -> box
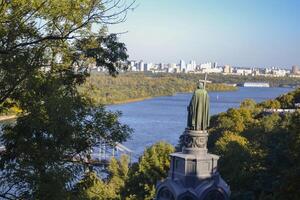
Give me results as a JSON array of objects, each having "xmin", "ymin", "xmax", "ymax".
[{"xmin": 156, "ymin": 129, "xmax": 230, "ymax": 200}]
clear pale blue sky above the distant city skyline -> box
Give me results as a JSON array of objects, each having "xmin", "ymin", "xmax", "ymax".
[{"xmin": 110, "ymin": 0, "xmax": 300, "ymax": 68}]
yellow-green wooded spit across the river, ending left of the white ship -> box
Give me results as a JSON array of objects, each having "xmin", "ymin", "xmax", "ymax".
[{"xmin": 79, "ymin": 74, "xmax": 237, "ymax": 106}]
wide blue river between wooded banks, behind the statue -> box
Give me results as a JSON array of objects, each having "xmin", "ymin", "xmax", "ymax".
[{"xmin": 107, "ymin": 87, "xmax": 291, "ymax": 158}]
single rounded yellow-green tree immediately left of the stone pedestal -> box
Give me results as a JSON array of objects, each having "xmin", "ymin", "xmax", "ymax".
[{"xmin": 123, "ymin": 142, "xmax": 175, "ymax": 200}]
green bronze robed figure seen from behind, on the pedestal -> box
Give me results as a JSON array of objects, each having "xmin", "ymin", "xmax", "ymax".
[{"xmin": 187, "ymin": 82, "xmax": 209, "ymax": 131}]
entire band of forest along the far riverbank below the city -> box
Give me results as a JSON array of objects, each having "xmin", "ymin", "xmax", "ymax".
[{"xmin": 79, "ymin": 73, "xmax": 300, "ymax": 105}]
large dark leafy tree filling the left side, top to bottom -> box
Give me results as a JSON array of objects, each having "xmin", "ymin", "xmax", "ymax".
[{"xmin": 0, "ymin": 0, "xmax": 131, "ymax": 200}]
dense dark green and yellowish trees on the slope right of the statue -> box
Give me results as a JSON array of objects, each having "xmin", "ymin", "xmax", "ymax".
[{"xmin": 209, "ymin": 89, "xmax": 300, "ymax": 199}]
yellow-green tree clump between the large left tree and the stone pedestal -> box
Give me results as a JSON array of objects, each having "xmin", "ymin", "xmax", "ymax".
[{"xmin": 70, "ymin": 142, "xmax": 174, "ymax": 200}]
